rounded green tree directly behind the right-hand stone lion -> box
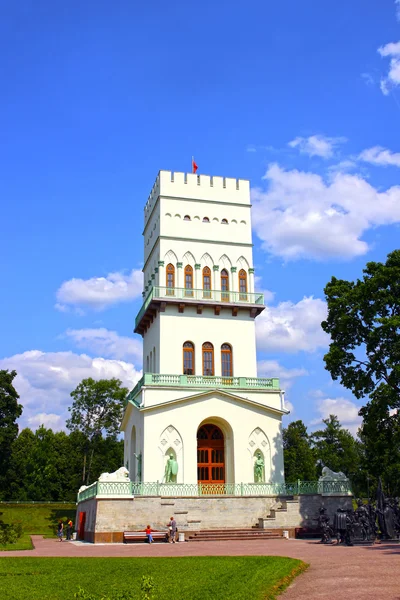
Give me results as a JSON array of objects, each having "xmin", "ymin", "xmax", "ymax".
[{"xmin": 311, "ymin": 415, "xmax": 360, "ymax": 478}]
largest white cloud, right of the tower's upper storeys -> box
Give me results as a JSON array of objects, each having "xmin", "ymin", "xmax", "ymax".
[{"xmin": 252, "ymin": 164, "xmax": 400, "ymax": 260}]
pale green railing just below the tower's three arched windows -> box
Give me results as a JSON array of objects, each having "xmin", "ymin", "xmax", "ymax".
[{"xmin": 126, "ymin": 373, "xmax": 280, "ymax": 406}]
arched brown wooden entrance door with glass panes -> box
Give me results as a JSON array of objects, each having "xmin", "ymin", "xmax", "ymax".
[{"xmin": 197, "ymin": 424, "xmax": 225, "ymax": 483}]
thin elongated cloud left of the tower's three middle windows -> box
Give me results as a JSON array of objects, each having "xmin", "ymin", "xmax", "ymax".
[{"xmin": 66, "ymin": 327, "xmax": 143, "ymax": 364}]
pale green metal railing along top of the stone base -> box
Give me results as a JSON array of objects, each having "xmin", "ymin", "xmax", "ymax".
[{"xmin": 78, "ymin": 481, "xmax": 352, "ymax": 502}]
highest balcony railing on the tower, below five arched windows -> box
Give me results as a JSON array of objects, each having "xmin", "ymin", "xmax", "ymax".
[{"xmin": 135, "ymin": 286, "xmax": 264, "ymax": 327}]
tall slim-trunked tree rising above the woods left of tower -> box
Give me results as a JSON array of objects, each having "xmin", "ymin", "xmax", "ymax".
[{"xmin": 67, "ymin": 378, "xmax": 129, "ymax": 483}]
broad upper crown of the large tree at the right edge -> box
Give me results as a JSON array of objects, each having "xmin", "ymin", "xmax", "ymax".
[{"xmin": 321, "ymin": 250, "xmax": 400, "ymax": 409}]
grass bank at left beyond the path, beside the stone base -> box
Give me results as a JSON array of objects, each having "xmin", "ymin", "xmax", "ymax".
[{"xmin": 0, "ymin": 504, "xmax": 76, "ymax": 551}]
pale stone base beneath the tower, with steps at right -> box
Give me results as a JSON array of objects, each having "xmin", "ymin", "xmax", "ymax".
[{"xmin": 76, "ymin": 494, "xmax": 352, "ymax": 543}]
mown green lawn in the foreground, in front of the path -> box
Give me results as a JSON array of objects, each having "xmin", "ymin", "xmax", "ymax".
[{"xmin": 0, "ymin": 556, "xmax": 307, "ymax": 600}]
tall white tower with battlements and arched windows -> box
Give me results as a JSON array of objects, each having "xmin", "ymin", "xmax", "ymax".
[{"xmin": 122, "ymin": 171, "xmax": 287, "ymax": 485}]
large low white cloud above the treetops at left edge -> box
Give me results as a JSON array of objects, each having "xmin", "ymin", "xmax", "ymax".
[{"xmin": 0, "ymin": 350, "xmax": 141, "ymax": 429}]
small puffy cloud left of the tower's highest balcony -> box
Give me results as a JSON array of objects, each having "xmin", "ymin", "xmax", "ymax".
[{"xmin": 55, "ymin": 269, "xmax": 143, "ymax": 311}]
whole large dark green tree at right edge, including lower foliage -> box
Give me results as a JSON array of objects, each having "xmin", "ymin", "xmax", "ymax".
[{"xmin": 321, "ymin": 250, "xmax": 400, "ymax": 489}]
